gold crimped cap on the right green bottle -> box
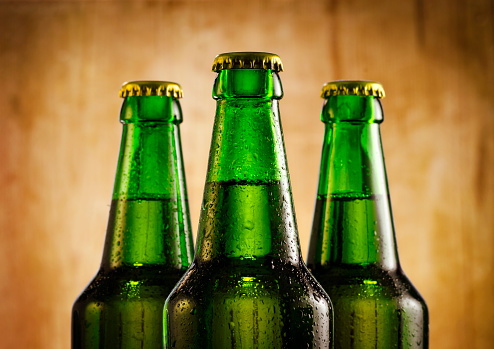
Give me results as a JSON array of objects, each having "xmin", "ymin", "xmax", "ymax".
[{"xmin": 321, "ymin": 80, "xmax": 385, "ymax": 98}]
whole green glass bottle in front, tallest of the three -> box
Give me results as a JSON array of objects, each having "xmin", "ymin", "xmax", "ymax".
[{"xmin": 164, "ymin": 52, "xmax": 333, "ymax": 349}]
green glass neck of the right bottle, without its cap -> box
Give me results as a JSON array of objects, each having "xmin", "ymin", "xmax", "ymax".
[{"xmin": 308, "ymin": 95, "xmax": 399, "ymax": 270}]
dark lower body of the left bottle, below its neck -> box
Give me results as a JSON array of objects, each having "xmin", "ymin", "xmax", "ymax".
[{"xmin": 72, "ymin": 268, "xmax": 183, "ymax": 349}]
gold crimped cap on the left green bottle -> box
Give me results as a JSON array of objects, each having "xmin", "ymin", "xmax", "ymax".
[{"xmin": 119, "ymin": 81, "xmax": 183, "ymax": 98}]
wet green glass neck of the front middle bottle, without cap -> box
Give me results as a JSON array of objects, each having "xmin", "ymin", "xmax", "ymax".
[{"xmin": 195, "ymin": 69, "xmax": 300, "ymax": 265}]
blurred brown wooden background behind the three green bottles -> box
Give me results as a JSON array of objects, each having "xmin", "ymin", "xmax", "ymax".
[{"xmin": 0, "ymin": 0, "xmax": 494, "ymax": 349}]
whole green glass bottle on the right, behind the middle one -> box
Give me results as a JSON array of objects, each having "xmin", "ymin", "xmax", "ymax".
[{"xmin": 307, "ymin": 81, "xmax": 429, "ymax": 349}]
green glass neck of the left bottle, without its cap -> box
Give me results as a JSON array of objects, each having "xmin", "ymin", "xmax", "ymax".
[{"xmin": 102, "ymin": 96, "xmax": 192, "ymax": 270}]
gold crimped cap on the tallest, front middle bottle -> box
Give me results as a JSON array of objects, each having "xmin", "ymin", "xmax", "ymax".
[{"xmin": 212, "ymin": 52, "xmax": 283, "ymax": 72}]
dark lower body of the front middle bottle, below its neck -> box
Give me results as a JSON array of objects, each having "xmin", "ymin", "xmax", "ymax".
[{"xmin": 165, "ymin": 260, "xmax": 332, "ymax": 349}]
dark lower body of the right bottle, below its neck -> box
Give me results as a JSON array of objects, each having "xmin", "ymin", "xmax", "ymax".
[{"xmin": 313, "ymin": 266, "xmax": 429, "ymax": 349}]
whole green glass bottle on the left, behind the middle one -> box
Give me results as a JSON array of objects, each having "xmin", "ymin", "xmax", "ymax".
[{"xmin": 72, "ymin": 81, "xmax": 193, "ymax": 349}]
